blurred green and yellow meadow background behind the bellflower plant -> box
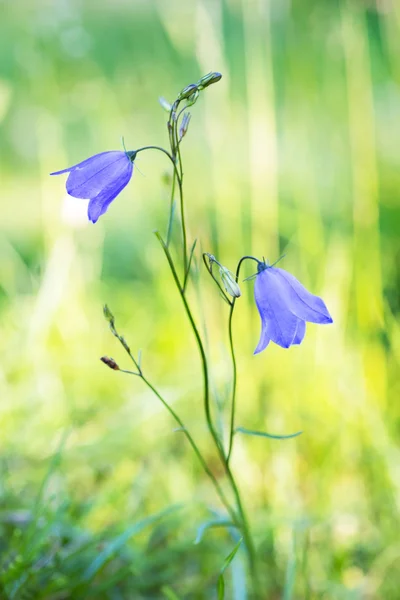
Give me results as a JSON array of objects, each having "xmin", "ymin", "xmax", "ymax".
[{"xmin": 0, "ymin": 0, "xmax": 400, "ymax": 600}]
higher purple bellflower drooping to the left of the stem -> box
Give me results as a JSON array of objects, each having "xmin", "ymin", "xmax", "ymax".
[{"xmin": 50, "ymin": 150, "xmax": 136, "ymax": 223}]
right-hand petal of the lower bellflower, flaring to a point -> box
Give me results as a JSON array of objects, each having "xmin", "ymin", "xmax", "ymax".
[{"xmin": 274, "ymin": 267, "xmax": 332, "ymax": 324}]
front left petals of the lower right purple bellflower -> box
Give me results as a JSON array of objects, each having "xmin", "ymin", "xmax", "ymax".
[{"xmin": 254, "ymin": 268, "xmax": 298, "ymax": 353}]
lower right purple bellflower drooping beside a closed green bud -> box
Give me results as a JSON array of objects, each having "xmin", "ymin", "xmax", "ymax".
[{"xmin": 254, "ymin": 262, "xmax": 332, "ymax": 354}]
